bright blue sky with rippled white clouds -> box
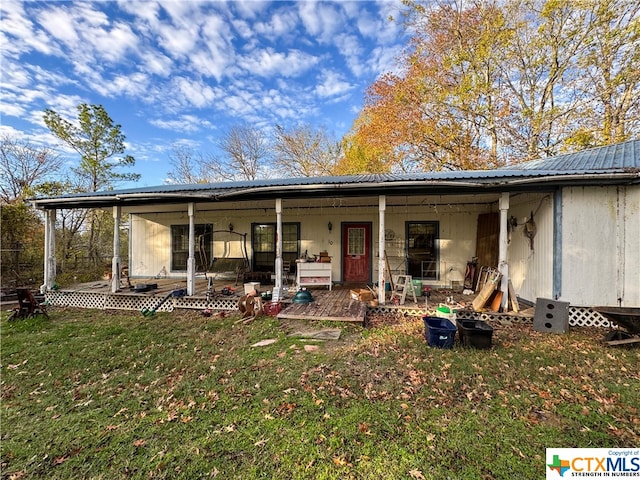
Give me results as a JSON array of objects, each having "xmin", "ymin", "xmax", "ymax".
[{"xmin": 0, "ymin": 0, "xmax": 406, "ymax": 186}]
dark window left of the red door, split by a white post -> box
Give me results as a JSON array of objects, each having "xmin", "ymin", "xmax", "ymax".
[{"xmin": 251, "ymin": 223, "xmax": 300, "ymax": 272}]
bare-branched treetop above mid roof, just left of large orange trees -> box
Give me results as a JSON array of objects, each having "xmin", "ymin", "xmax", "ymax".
[{"xmin": 273, "ymin": 125, "xmax": 341, "ymax": 177}]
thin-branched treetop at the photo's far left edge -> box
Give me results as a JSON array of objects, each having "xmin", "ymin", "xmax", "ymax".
[{"xmin": 0, "ymin": 135, "xmax": 62, "ymax": 202}]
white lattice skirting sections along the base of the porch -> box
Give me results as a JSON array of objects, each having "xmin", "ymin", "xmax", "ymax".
[{"xmin": 45, "ymin": 290, "xmax": 612, "ymax": 328}]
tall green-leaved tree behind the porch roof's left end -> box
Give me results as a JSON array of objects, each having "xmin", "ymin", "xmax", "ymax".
[{"xmin": 44, "ymin": 103, "xmax": 140, "ymax": 266}]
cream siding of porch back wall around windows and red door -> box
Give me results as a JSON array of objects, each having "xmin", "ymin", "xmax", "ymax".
[{"xmin": 130, "ymin": 204, "xmax": 489, "ymax": 285}]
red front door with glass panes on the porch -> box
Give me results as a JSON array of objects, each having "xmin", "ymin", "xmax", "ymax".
[{"xmin": 342, "ymin": 223, "xmax": 371, "ymax": 283}]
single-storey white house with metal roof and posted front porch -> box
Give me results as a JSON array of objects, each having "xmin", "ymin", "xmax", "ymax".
[{"xmin": 32, "ymin": 140, "xmax": 640, "ymax": 307}]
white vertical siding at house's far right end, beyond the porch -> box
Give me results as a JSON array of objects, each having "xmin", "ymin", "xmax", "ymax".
[{"xmin": 562, "ymin": 187, "xmax": 640, "ymax": 306}]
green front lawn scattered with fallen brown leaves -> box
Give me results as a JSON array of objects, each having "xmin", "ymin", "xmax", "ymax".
[{"xmin": 0, "ymin": 309, "xmax": 640, "ymax": 480}]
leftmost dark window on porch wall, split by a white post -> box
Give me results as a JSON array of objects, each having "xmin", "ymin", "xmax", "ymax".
[{"xmin": 171, "ymin": 223, "xmax": 213, "ymax": 272}]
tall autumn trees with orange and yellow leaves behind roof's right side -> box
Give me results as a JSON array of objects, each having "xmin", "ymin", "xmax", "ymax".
[{"xmin": 356, "ymin": 0, "xmax": 640, "ymax": 171}]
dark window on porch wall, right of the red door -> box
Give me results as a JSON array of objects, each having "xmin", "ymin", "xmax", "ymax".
[{"xmin": 406, "ymin": 222, "xmax": 440, "ymax": 280}]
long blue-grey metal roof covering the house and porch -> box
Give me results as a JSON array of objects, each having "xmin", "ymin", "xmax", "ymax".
[{"xmin": 31, "ymin": 140, "xmax": 640, "ymax": 208}]
